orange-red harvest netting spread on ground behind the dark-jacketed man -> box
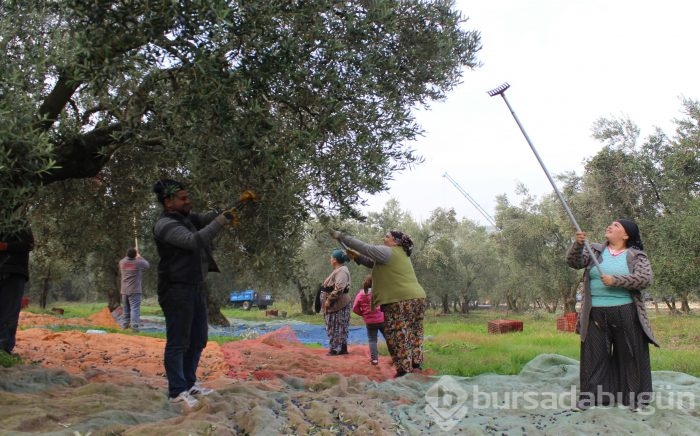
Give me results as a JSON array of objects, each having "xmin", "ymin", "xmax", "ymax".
[{"xmin": 15, "ymin": 308, "xmax": 434, "ymax": 383}]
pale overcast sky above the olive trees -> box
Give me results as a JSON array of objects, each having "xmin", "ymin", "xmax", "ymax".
[{"xmin": 365, "ymin": 0, "xmax": 700, "ymax": 225}]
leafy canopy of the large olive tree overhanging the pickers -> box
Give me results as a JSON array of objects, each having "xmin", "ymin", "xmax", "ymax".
[{"xmin": 0, "ymin": 0, "xmax": 480, "ymax": 234}]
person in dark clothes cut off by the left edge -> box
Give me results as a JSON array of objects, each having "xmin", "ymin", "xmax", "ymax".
[{"xmin": 0, "ymin": 227, "xmax": 34, "ymax": 354}]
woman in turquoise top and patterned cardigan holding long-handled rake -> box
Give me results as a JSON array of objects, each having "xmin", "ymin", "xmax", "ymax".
[{"xmin": 566, "ymin": 219, "xmax": 659, "ymax": 411}]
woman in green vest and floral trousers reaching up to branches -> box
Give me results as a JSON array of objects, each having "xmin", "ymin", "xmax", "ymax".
[{"xmin": 330, "ymin": 230, "xmax": 425, "ymax": 377}]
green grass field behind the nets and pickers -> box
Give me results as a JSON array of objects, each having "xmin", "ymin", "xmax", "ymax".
[{"xmin": 17, "ymin": 300, "xmax": 700, "ymax": 377}]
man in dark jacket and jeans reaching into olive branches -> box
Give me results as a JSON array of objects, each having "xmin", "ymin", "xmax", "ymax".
[{"xmin": 153, "ymin": 179, "xmax": 235, "ymax": 409}]
